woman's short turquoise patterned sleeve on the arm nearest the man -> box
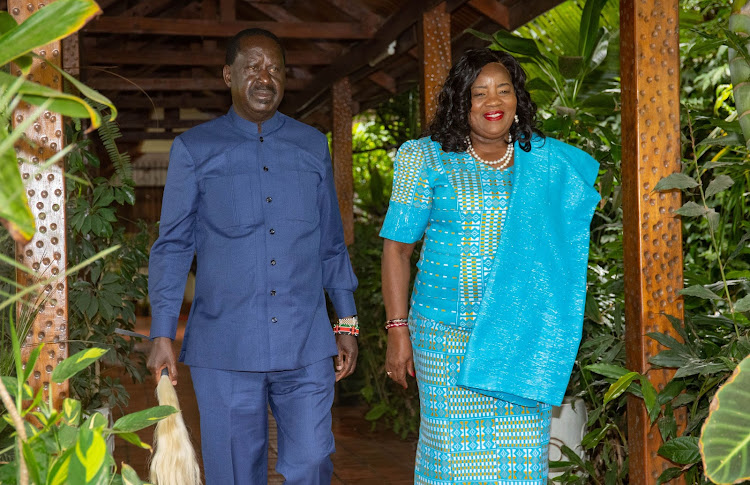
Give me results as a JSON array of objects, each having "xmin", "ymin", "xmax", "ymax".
[{"xmin": 380, "ymin": 140, "xmax": 432, "ymax": 243}]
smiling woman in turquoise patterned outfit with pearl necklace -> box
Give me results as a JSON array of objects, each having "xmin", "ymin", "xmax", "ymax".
[{"xmin": 380, "ymin": 49, "xmax": 598, "ymax": 485}]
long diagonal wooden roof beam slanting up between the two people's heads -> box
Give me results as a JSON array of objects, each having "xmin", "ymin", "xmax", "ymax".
[{"xmin": 287, "ymin": 0, "xmax": 467, "ymax": 115}]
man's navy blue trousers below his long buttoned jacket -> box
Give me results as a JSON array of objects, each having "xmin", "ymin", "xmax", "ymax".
[{"xmin": 190, "ymin": 358, "xmax": 335, "ymax": 485}]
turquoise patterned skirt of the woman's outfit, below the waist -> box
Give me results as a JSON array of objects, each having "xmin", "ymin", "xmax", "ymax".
[{"xmin": 409, "ymin": 311, "xmax": 551, "ymax": 485}]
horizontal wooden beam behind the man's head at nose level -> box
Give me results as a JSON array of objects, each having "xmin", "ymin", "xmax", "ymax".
[{"xmin": 87, "ymin": 77, "xmax": 307, "ymax": 91}]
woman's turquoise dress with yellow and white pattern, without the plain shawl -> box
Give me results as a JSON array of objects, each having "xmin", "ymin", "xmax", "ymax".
[{"xmin": 380, "ymin": 138, "xmax": 551, "ymax": 485}]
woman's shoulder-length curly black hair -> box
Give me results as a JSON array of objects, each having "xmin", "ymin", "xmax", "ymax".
[{"xmin": 427, "ymin": 49, "xmax": 544, "ymax": 152}]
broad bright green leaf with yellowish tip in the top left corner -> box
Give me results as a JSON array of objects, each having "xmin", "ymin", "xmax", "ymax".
[{"xmin": 0, "ymin": 0, "xmax": 101, "ymax": 65}]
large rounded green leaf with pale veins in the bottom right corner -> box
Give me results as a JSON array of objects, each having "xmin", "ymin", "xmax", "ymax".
[{"xmin": 700, "ymin": 357, "xmax": 750, "ymax": 484}]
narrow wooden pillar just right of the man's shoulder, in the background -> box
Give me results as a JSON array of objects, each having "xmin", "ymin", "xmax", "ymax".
[{"xmin": 332, "ymin": 77, "xmax": 354, "ymax": 246}]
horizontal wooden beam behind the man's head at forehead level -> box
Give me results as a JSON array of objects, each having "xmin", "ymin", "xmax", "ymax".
[{"xmin": 86, "ymin": 47, "xmax": 333, "ymax": 66}]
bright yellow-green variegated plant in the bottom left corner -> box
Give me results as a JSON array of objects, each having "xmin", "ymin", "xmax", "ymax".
[{"xmin": 0, "ymin": 314, "xmax": 177, "ymax": 485}]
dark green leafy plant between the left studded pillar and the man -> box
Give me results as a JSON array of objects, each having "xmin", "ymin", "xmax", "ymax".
[{"xmin": 66, "ymin": 109, "xmax": 151, "ymax": 409}]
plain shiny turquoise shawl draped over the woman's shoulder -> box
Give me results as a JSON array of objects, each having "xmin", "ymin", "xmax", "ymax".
[{"xmin": 458, "ymin": 134, "xmax": 600, "ymax": 406}]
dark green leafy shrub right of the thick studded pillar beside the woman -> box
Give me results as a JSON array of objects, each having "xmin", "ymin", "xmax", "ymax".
[{"xmin": 590, "ymin": 102, "xmax": 750, "ymax": 484}]
